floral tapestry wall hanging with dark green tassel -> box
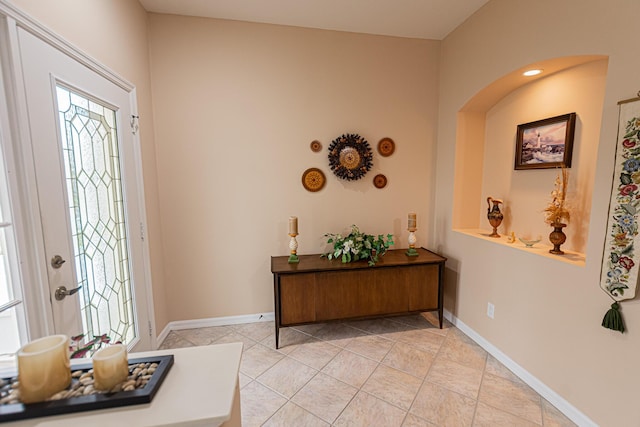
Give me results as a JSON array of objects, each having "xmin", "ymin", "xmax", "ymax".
[{"xmin": 600, "ymin": 93, "xmax": 640, "ymax": 332}]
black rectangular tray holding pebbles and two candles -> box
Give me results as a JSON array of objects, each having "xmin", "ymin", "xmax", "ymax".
[{"xmin": 0, "ymin": 354, "xmax": 173, "ymax": 423}]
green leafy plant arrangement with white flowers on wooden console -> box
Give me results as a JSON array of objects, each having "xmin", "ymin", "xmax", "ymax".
[{"xmin": 322, "ymin": 224, "xmax": 393, "ymax": 266}]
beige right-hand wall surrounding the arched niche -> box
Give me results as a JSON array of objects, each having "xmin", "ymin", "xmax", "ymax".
[{"xmin": 434, "ymin": 0, "xmax": 640, "ymax": 426}]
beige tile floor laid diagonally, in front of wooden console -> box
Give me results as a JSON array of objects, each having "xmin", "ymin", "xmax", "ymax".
[{"xmin": 162, "ymin": 313, "xmax": 574, "ymax": 427}]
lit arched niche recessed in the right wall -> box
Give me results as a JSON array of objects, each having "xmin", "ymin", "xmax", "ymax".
[{"xmin": 452, "ymin": 55, "xmax": 608, "ymax": 264}]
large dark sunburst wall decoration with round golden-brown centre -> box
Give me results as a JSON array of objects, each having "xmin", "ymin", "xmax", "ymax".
[{"xmin": 329, "ymin": 133, "xmax": 373, "ymax": 181}]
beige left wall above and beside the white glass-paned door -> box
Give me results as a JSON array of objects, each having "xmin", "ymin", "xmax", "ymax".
[{"xmin": 10, "ymin": 0, "xmax": 170, "ymax": 331}]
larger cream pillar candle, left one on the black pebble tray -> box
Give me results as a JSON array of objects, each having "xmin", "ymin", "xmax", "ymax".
[{"xmin": 17, "ymin": 335, "xmax": 71, "ymax": 403}]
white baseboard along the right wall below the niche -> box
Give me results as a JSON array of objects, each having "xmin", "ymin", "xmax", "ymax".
[{"xmin": 444, "ymin": 310, "xmax": 598, "ymax": 427}]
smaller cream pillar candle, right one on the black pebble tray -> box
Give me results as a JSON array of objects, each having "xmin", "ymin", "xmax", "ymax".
[{"xmin": 93, "ymin": 344, "xmax": 129, "ymax": 390}]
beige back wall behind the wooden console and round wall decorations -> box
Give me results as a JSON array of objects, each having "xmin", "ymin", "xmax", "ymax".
[{"xmin": 149, "ymin": 14, "xmax": 439, "ymax": 320}]
